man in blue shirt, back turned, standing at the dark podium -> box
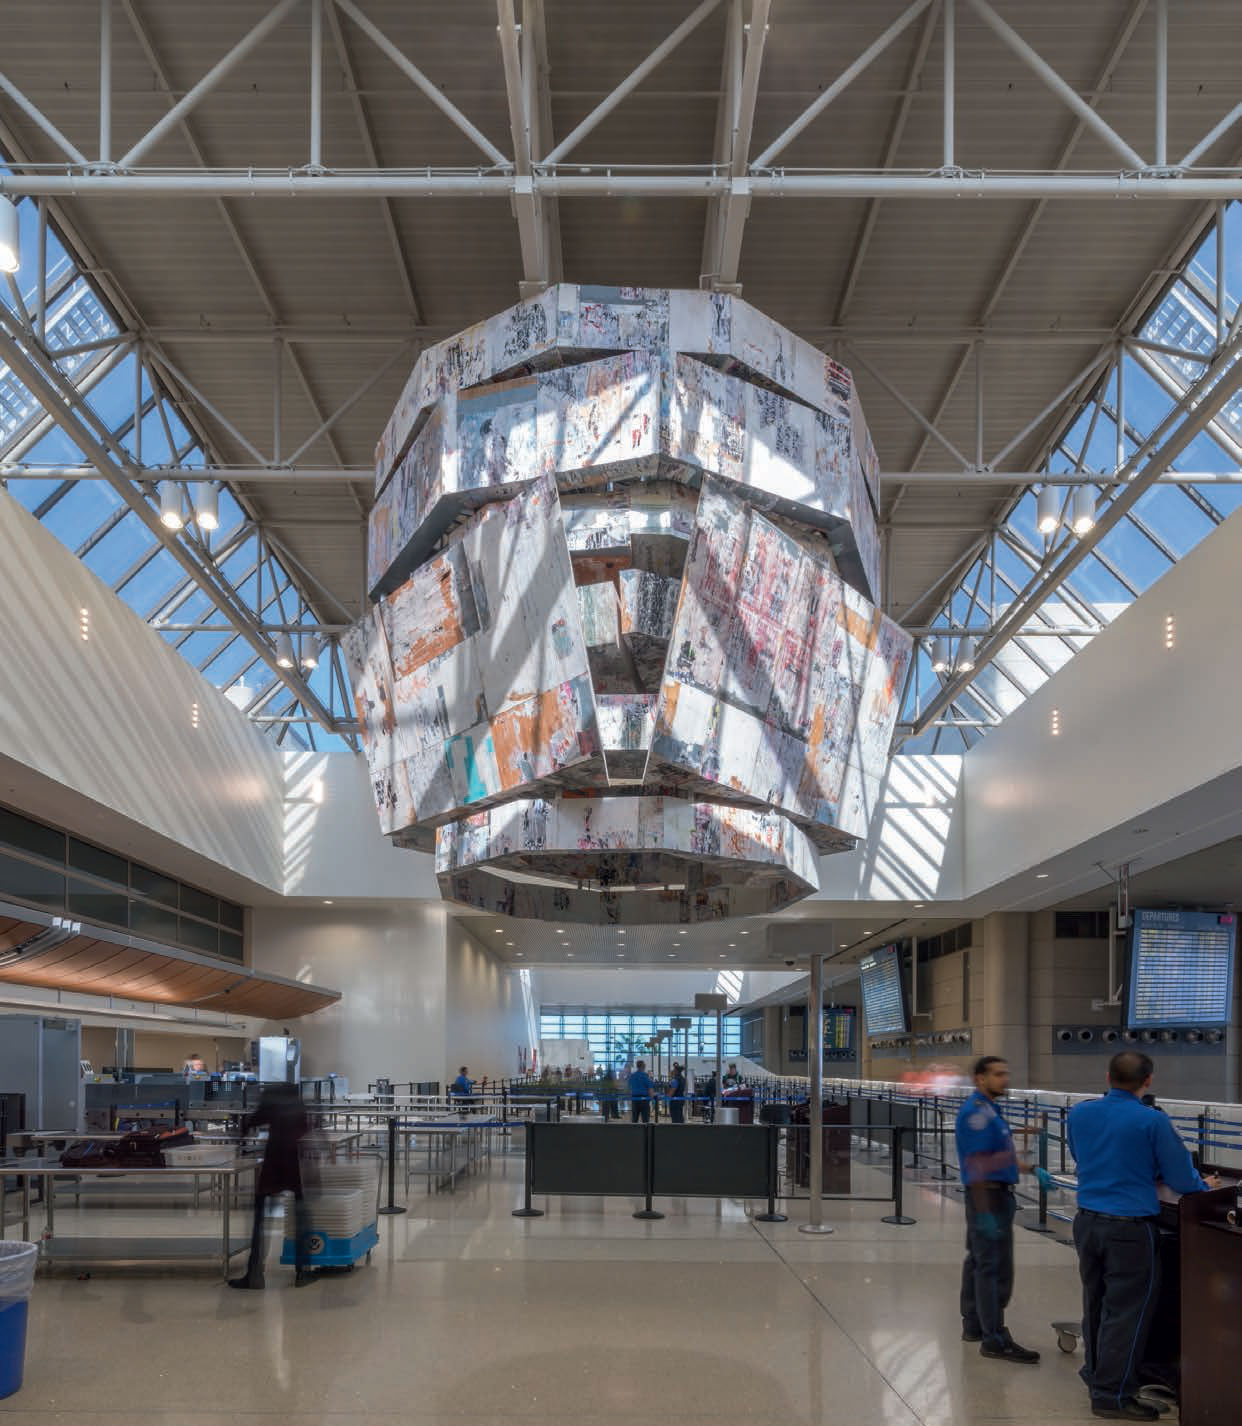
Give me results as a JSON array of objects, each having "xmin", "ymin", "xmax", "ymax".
[{"xmin": 1068, "ymin": 1050, "xmax": 1212, "ymax": 1422}]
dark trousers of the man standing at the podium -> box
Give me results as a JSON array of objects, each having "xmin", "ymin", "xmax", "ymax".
[{"xmin": 1074, "ymin": 1208, "xmax": 1161, "ymax": 1406}]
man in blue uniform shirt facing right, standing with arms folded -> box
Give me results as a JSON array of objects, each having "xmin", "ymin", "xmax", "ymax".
[{"xmin": 957, "ymin": 1055, "xmax": 1040, "ymax": 1365}]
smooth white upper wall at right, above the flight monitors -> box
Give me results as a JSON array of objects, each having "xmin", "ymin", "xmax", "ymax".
[{"xmin": 964, "ymin": 516, "xmax": 1242, "ymax": 894}]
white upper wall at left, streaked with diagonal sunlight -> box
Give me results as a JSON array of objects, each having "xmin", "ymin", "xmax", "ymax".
[{"xmin": 0, "ymin": 491, "xmax": 284, "ymax": 890}]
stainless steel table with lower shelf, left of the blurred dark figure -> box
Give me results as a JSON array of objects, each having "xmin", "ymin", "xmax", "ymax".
[{"xmin": 0, "ymin": 1158, "xmax": 260, "ymax": 1276}]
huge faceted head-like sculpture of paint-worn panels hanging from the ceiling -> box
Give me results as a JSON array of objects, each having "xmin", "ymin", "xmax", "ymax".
[{"xmin": 344, "ymin": 284, "xmax": 911, "ymax": 925}]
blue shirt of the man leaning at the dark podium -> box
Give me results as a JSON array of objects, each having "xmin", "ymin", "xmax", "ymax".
[{"xmin": 1068, "ymin": 1089, "xmax": 1208, "ymax": 1218}]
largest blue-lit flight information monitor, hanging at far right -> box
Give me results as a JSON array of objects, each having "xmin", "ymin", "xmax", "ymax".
[{"xmin": 1125, "ymin": 911, "xmax": 1236, "ymax": 1030}]
